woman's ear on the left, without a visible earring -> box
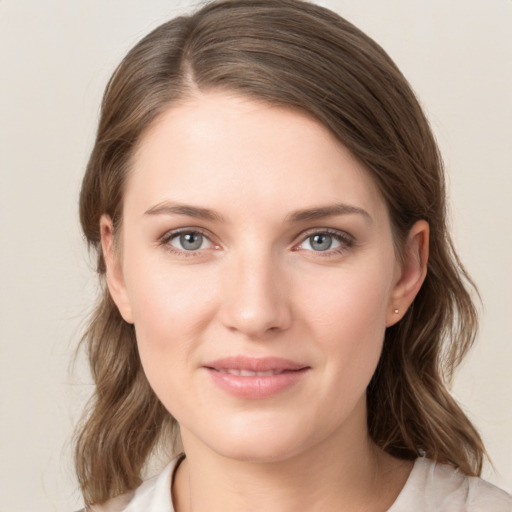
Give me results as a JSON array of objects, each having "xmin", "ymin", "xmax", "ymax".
[{"xmin": 100, "ymin": 215, "xmax": 133, "ymax": 324}]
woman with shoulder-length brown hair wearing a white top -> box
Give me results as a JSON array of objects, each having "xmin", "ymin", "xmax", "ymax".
[{"xmin": 76, "ymin": 0, "xmax": 512, "ymax": 512}]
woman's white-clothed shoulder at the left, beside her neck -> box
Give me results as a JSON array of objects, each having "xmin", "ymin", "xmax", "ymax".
[{"xmin": 84, "ymin": 456, "xmax": 182, "ymax": 512}]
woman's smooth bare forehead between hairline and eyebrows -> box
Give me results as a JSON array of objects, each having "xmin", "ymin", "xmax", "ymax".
[{"xmin": 125, "ymin": 92, "xmax": 385, "ymax": 223}]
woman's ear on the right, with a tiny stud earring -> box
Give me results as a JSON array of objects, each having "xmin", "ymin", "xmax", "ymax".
[{"xmin": 386, "ymin": 220, "xmax": 430, "ymax": 327}]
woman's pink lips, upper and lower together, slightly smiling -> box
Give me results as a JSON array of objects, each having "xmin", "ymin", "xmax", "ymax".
[{"xmin": 203, "ymin": 356, "xmax": 310, "ymax": 399}]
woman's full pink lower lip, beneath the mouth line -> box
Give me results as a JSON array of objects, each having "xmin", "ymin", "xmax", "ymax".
[{"xmin": 206, "ymin": 368, "xmax": 308, "ymax": 399}]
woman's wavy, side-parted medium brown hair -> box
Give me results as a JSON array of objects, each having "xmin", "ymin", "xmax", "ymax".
[{"xmin": 76, "ymin": 0, "xmax": 484, "ymax": 504}]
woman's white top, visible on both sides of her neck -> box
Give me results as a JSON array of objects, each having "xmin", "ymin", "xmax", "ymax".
[{"xmin": 92, "ymin": 457, "xmax": 512, "ymax": 512}]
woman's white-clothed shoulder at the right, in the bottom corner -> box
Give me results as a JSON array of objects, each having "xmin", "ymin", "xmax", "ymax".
[{"xmin": 389, "ymin": 458, "xmax": 512, "ymax": 512}]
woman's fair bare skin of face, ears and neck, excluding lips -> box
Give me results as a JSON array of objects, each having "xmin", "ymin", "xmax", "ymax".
[{"xmin": 101, "ymin": 92, "xmax": 428, "ymax": 512}]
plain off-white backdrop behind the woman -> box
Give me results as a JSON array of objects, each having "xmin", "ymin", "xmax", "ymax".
[{"xmin": 0, "ymin": 0, "xmax": 512, "ymax": 512}]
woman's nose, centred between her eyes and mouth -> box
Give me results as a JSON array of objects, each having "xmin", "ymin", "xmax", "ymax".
[{"xmin": 220, "ymin": 249, "xmax": 292, "ymax": 339}]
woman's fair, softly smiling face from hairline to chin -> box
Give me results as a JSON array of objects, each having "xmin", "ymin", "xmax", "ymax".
[{"xmin": 102, "ymin": 92, "xmax": 424, "ymax": 460}]
